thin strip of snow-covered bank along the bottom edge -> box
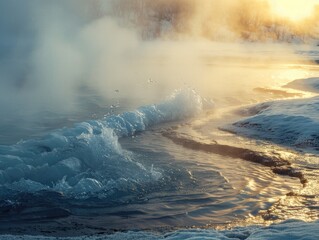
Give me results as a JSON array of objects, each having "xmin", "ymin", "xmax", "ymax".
[{"xmin": 0, "ymin": 220, "xmax": 319, "ymax": 240}]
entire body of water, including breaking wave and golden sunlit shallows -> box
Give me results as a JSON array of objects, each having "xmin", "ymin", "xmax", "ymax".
[{"xmin": 0, "ymin": 50, "xmax": 317, "ymax": 236}]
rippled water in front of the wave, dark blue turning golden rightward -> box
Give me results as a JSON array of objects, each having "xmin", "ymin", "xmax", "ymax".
[{"xmin": 1, "ymin": 98, "xmax": 300, "ymax": 235}]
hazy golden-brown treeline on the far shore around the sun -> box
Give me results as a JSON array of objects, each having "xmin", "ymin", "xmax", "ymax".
[{"xmin": 113, "ymin": 0, "xmax": 319, "ymax": 42}]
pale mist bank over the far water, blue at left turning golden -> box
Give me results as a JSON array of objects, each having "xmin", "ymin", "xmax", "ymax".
[{"xmin": 0, "ymin": 0, "xmax": 317, "ymax": 139}]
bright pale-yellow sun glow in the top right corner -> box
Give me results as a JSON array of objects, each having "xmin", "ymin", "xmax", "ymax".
[{"xmin": 268, "ymin": 0, "xmax": 319, "ymax": 21}]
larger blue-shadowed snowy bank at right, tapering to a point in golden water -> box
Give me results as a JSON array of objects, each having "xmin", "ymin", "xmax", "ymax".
[{"xmin": 225, "ymin": 97, "xmax": 319, "ymax": 151}]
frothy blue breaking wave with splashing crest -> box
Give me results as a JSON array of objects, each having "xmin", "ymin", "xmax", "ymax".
[{"xmin": 0, "ymin": 89, "xmax": 203, "ymax": 198}]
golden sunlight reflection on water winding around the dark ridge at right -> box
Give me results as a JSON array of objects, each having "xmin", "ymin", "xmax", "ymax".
[{"xmin": 185, "ymin": 93, "xmax": 319, "ymax": 226}]
